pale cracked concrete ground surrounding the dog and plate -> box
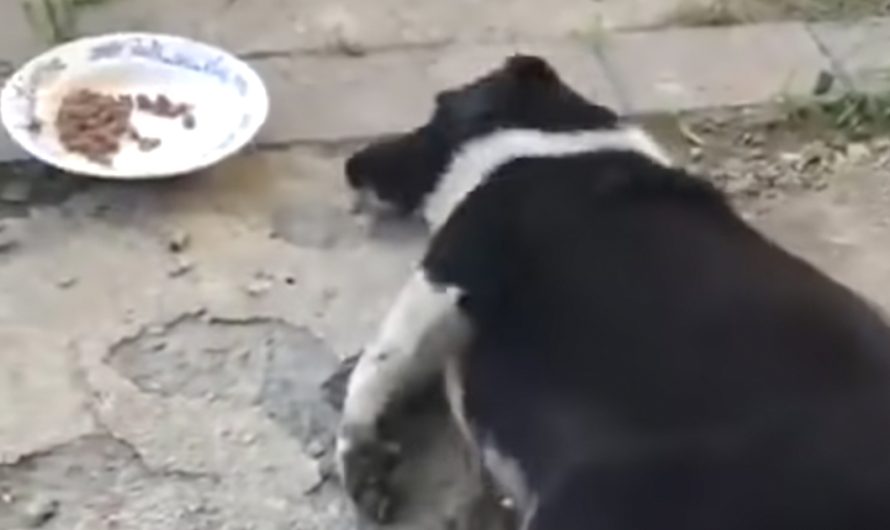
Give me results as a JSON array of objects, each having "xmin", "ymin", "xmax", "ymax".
[{"xmin": 0, "ymin": 0, "xmax": 890, "ymax": 530}]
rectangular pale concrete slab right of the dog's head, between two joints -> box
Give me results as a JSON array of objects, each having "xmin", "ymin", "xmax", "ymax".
[{"xmin": 601, "ymin": 22, "xmax": 831, "ymax": 113}]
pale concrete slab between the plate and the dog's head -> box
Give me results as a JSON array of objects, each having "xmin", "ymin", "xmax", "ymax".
[{"xmin": 253, "ymin": 41, "xmax": 620, "ymax": 144}]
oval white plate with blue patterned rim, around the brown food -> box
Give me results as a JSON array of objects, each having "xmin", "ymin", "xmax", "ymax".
[{"xmin": 0, "ymin": 33, "xmax": 269, "ymax": 179}]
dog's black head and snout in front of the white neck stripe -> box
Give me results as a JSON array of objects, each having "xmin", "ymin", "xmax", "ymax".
[{"xmin": 346, "ymin": 55, "xmax": 618, "ymax": 214}]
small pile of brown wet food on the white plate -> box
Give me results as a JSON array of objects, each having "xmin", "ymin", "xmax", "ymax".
[{"xmin": 56, "ymin": 90, "xmax": 195, "ymax": 166}]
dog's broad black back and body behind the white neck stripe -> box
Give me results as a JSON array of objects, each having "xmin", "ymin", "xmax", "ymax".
[{"xmin": 425, "ymin": 153, "xmax": 890, "ymax": 530}]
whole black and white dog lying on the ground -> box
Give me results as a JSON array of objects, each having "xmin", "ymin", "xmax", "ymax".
[{"xmin": 338, "ymin": 56, "xmax": 890, "ymax": 530}]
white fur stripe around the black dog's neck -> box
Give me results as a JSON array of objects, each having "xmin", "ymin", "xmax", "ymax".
[{"xmin": 423, "ymin": 128, "xmax": 671, "ymax": 229}]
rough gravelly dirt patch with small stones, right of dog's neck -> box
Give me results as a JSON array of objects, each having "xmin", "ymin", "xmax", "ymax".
[{"xmin": 642, "ymin": 106, "xmax": 890, "ymax": 216}]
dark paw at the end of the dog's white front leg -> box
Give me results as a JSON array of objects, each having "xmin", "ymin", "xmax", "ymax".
[{"xmin": 337, "ymin": 424, "xmax": 401, "ymax": 523}]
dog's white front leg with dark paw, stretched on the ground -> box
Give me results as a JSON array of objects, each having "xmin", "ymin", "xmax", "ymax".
[{"xmin": 337, "ymin": 270, "xmax": 468, "ymax": 521}]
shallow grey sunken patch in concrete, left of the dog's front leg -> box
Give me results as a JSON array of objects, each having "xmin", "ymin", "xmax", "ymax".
[{"xmin": 108, "ymin": 316, "xmax": 338, "ymax": 450}]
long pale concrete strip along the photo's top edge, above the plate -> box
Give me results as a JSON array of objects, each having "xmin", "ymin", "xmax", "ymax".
[{"xmin": 81, "ymin": 0, "xmax": 710, "ymax": 53}]
